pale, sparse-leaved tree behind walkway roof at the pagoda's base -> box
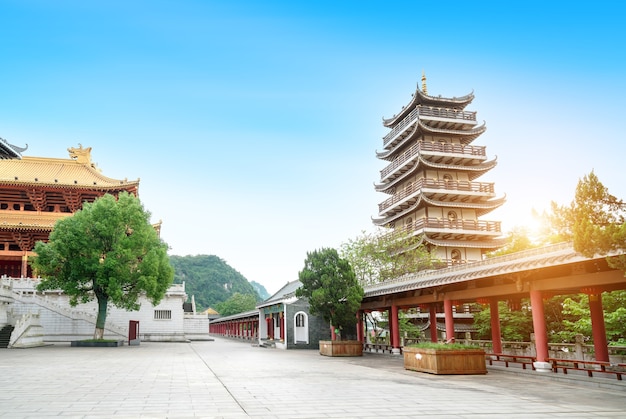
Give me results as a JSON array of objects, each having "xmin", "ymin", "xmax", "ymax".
[{"xmin": 340, "ymin": 231, "xmax": 436, "ymax": 286}]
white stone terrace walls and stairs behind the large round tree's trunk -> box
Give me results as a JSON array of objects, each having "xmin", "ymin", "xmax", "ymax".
[{"xmin": 0, "ymin": 277, "xmax": 209, "ymax": 348}]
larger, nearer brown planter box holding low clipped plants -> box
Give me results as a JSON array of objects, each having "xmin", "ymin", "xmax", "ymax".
[{"xmin": 402, "ymin": 347, "xmax": 487, "ymax": 374}]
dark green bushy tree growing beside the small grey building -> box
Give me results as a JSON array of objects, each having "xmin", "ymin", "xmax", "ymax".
[{"xmin": 296, "ymin": 248, "xmax": 363, "ymax": 339}]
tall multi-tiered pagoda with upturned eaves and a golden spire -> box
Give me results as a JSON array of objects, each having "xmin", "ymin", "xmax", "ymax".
[{"xmin": 373, "ymin": 75, "xmax": 505, "ymax": 265}]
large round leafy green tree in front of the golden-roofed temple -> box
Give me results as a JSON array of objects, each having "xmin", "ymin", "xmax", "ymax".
[{"xmin": 32, "ymin": 192, "xmax": 174, "ymax": 339}]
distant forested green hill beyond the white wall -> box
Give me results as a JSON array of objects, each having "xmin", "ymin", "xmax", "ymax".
[{"xmin": 170, "ymin": 255, "xmax": 267, "ymax": 311}]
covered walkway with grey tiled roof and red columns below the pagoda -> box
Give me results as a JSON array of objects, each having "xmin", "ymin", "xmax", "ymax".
[{"xmin": 359, "ymin": 243, "xmax": 626, "ymax": 369}]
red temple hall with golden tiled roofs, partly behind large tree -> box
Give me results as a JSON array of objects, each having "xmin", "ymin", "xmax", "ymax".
[{"xmin": 0, "ymin": 138, "xmax": 139, "ymax": 278}]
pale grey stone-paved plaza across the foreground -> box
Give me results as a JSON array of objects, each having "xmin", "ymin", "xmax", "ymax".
[{"xmin": 0, "ymin": 338, "xmax": 626, "ymax": 418}]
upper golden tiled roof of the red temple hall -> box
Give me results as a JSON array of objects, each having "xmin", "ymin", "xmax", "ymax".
[{"xmin": 0, "ymin": 145, "xmax": 139, "ymax": 190}]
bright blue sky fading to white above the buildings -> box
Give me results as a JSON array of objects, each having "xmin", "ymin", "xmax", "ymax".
[{"xmin": 0, "ymin": 0, "xmax": 626, "ymax": 293}]
